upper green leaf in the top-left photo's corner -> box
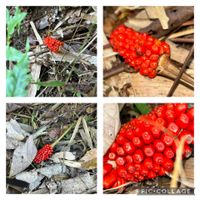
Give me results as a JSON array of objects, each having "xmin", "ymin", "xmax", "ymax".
[{"xmin": 6, "ymin": 7, "xmax": 27, "ymax": 44}]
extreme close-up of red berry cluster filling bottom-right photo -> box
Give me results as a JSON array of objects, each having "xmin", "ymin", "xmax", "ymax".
[{"xmin": 103, "ymin": 104, "xmax": 194, "ymax": 189}]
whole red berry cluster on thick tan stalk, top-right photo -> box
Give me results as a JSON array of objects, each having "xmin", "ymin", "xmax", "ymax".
[{"xmin": 110, "ymin": 25, "xmax": 170, "ymax": 78}]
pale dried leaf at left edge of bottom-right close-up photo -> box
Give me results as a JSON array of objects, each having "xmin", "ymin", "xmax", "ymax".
[{"xmin": 103, "ymin": 104, "xmax": 121, "ymax": 154}]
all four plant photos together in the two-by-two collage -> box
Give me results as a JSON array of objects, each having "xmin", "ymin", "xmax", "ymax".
[{"xmin": 5, "ymin": 4, "xmax": 195, "ymax": 196}]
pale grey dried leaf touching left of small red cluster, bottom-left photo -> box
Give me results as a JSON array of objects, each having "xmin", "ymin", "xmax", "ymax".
[{"xmin": 10, "ymin": 135, "xmax": 37, "ymax": 176}]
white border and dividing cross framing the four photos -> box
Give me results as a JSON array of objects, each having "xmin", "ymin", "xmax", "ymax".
[{"xmin": 0, "ymin": 0, "xmax": 200, "ymax": 200}]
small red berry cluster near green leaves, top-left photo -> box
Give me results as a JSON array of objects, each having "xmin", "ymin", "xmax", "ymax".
[{"xmin": 43, "ymin": 37, "xmax": 64, "ymax": 53}]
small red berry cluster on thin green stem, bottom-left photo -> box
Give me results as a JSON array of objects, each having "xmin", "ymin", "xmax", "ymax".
[{"xmin": 33, "ymin": 144, "xmax": 53, "ymax": 164}]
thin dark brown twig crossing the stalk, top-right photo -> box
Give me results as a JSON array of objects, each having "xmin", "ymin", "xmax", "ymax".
[{"xmin": 167, "ymin": 45, "xmax": 194, "ymax": 97}]
